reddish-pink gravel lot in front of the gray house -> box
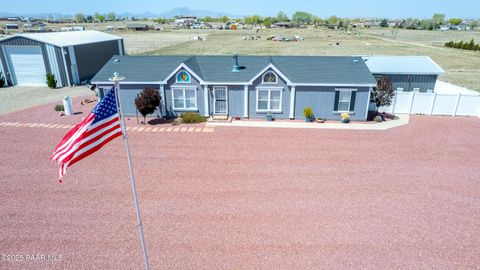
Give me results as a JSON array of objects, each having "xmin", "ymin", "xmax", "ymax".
[{"xmin": 0, "ymin": 99, "xmax": 480, "ymax": 269}]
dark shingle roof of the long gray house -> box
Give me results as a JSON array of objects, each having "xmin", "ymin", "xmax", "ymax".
[{"xmin": 92, "ymin": 56, "xmax": 376, "ymax": 85}]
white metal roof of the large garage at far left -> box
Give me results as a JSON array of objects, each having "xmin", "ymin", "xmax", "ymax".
[{"xmin": 0, "ymin": 30, "xmax": 122, "ymax": 47}]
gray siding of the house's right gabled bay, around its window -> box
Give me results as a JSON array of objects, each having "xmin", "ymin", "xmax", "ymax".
[{"xmin": 248, "ymin": 70, "xmax": 290, "ymax": 119}]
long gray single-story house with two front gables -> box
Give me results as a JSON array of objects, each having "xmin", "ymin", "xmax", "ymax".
[{"xmin": 92, "ymin": 56, "xmax": 376, "ymax": 121}]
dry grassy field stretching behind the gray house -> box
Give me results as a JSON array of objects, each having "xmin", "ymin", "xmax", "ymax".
[{"xmin": 136, "ymin": 28, "xmax": 480, "ymax": 91}]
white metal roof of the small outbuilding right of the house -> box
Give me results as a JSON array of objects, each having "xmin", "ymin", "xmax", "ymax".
[{"xmin": 363, "ymin": 56, "xmax": 445, "ymax": 75}]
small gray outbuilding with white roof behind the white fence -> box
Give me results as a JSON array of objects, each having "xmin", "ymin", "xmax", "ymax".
[{"xmin": 363, "ymin": 56, "xmax": 445, "ymax": 92}]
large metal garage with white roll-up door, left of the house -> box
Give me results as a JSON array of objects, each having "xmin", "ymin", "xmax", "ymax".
[{"xmin": 0, "ymin": 30, "xmax": 124, "ymax": 86}]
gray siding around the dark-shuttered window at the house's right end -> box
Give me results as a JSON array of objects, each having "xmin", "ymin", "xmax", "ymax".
[{"xmin": 295, "ymin": 86, "xmax": 369, "ymax": 121}]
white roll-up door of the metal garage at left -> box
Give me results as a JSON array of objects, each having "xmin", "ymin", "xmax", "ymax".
[{"xmin": 7, "ymin": 46, "xmax": 46, "ymax": 86}]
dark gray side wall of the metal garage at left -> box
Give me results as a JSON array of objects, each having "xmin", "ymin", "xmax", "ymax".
[{"xmin": 74, "ymin": 40, "xmax": 120, "ymax": 82}]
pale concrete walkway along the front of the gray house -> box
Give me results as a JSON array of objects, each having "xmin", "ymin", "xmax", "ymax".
[{"xmin": 206, "ymin": 114, "xmax": 409, "ymax": 130}]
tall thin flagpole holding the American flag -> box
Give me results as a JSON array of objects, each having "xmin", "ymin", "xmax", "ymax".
[{"xmin": 109, "ymin": 72, "xmax": 150, "ymax": 270}]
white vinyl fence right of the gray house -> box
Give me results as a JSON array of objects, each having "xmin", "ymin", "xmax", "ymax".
[{"xmin": 378, "ymin": 91, "xmax": 480, "ymax": 117}]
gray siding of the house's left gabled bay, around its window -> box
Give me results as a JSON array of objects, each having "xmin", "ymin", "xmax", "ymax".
[{"xmin": 164, "ymin": 69, "xmax": 205, "ymax": 118}]
